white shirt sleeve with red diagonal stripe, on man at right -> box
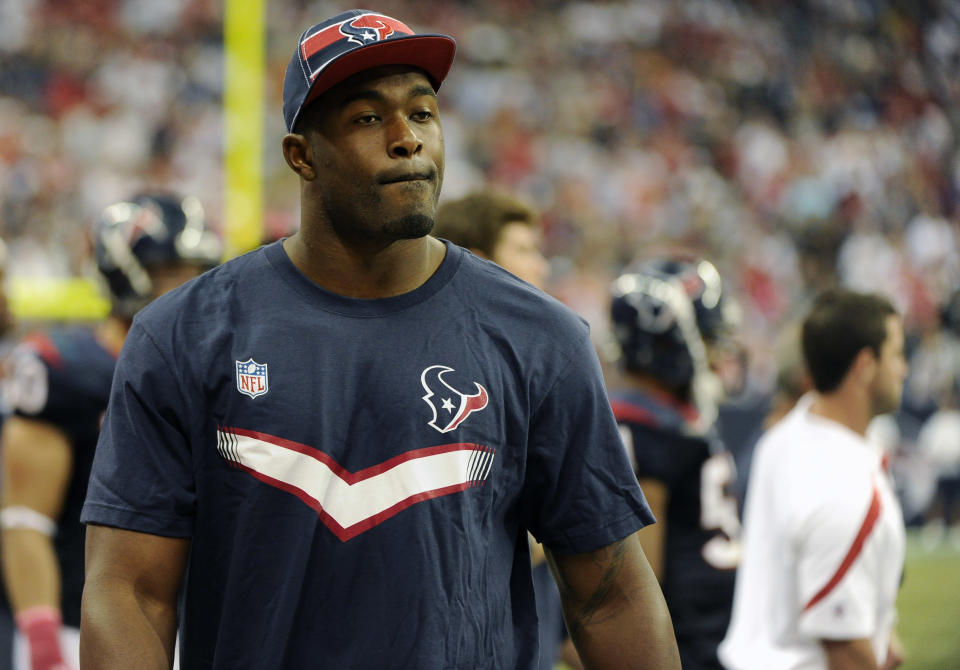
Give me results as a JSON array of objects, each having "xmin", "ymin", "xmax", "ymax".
[{"xmin": 797, "ymin": 482, "xmax": 881, "ymax": 640}]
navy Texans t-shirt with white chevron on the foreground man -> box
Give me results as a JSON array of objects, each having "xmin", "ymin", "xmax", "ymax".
[{"xmin": 83, "ymin": 243, "xmax": 652, "ymax": 670}]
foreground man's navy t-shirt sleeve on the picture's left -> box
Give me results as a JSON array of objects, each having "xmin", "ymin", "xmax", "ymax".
[{"xmin": 81, "ymin": 322, "xmax": 196, "ymax": 537}]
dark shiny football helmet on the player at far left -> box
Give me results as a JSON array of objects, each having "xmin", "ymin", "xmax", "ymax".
[{"xmin": 93, "ymin": 193, "xmax": 223, "ymax": 317}]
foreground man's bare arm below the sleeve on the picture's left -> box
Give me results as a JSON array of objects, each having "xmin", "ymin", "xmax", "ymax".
[{"xmin": 80, "ymin": 524, "xmax": 190, "ymax": 670}]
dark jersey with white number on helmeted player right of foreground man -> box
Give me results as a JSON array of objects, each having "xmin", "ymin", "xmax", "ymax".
[{"xmin": 610, "ymin": 390, "xmax": 740, "ymax": 670}]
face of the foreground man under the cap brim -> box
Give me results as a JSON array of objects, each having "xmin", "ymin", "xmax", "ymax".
[{"xmin": 304, "ymin": 66, "xmax": 443, "ymax": 242}]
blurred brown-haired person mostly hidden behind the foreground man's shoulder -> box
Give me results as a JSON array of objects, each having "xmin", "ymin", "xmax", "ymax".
[{"xmin": 433, "ymin": 190, "xmax": 583, "ymax": 670}]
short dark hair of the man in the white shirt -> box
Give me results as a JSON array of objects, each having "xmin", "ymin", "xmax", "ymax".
[{"xmin": 802, "ymin": 289, "xmax": 897, "ymax": 393}]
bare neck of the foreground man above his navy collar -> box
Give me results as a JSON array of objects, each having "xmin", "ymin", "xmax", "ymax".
[{"xmin": 283, "ymin": 230, "xmax": 446, "ymax": 299}]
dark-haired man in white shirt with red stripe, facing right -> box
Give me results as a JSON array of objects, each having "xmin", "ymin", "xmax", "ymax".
[{"xmin": 720, "ymin": 290, "xmax": 907, "ymax": 670}]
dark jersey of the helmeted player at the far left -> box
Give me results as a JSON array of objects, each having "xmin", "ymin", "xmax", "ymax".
[{"xmin": 5, "ymin": 327, "xmax": 117, "ymax": 628}]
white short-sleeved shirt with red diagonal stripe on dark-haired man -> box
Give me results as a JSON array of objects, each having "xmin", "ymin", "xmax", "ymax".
[{"xmin": 720, "ymin": 394, "xmax": 905, "ymax": 670}]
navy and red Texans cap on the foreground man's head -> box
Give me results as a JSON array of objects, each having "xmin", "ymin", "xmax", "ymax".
[{"xmin": 283, "ymin": 9, "xmax": 457, "ymax": 132}]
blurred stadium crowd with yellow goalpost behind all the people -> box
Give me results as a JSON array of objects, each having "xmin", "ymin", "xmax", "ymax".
[{"xmin": 0, "ymin": 0, "xmax": 960, "ymax": 670}]
